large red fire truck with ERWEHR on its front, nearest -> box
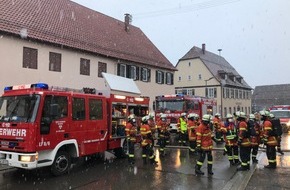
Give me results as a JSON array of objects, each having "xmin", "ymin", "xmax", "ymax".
[{"xmin": 0, "ymin": 83, "xmax": 149, "ymax": 175}]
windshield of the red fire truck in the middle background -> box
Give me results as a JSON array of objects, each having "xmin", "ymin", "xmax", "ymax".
[{"xmin": 156, "ymin": 100, "xmax": 185, "ymax": 112}]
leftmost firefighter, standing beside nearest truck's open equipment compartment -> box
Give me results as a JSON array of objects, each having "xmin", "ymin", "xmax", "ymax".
[{"xmin": 125, "ymin": 114, "xmax": 137, "ymax": 165}]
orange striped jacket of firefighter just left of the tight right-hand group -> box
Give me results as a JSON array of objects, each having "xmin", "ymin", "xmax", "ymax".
[{"xmin": 221, "ymin": 122, "xmax": 238, "ymax": 146}]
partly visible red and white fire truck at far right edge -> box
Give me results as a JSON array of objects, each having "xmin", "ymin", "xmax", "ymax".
[{"xmin": 270, "ymin": 105, "xmax": 290, "ymax": 133}]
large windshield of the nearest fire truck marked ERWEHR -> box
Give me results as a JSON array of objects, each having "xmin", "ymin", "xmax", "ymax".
[{"xmin": 0, "ymin": 95, "xmax": 40, "ymax": 122}]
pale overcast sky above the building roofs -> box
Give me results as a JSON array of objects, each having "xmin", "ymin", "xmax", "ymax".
[{"xmin": 73, "ymin": 0, "xmax": 290, "ymax": 88}]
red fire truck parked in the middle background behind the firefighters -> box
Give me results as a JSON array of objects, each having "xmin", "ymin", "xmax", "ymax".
[{"xmin": 155, "ymin": 94, "xmax": 217, "ymax": 132}]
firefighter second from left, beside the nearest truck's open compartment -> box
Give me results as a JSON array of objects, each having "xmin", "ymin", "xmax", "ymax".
[{"xmin": 140, "ymin": 116, "xmax": 157, "ymax": 165}]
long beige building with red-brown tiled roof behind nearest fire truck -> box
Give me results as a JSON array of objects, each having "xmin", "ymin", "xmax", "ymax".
[{"xmin": 0, "ymin": 0, "xmax": 176, "ymax": 109}]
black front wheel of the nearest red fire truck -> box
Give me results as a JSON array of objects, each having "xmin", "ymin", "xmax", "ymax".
[{"xmin": 51, "ymin": 151, "xmax": 71, "ymax": 176}]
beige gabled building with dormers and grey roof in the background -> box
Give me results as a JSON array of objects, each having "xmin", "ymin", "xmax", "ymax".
[{"xmin": 174, "ymin": 44, "xmax": 252, "ymax": 117}]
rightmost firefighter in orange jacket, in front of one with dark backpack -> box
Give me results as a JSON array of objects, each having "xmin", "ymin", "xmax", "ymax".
[{"xmin": 260, "ymin": 111, "xmax": 278, "ymax": 169}]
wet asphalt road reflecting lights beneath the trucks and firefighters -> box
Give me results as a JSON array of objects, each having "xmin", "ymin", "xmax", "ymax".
[{"xmin": 0, "ymin": 136, "xmax": 290, "ymax": 190}]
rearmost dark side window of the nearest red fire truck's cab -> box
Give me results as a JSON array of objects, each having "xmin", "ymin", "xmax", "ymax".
[{"xmin": 89, "ymin": 99, "xmax": 103, "ymax": 120}]
